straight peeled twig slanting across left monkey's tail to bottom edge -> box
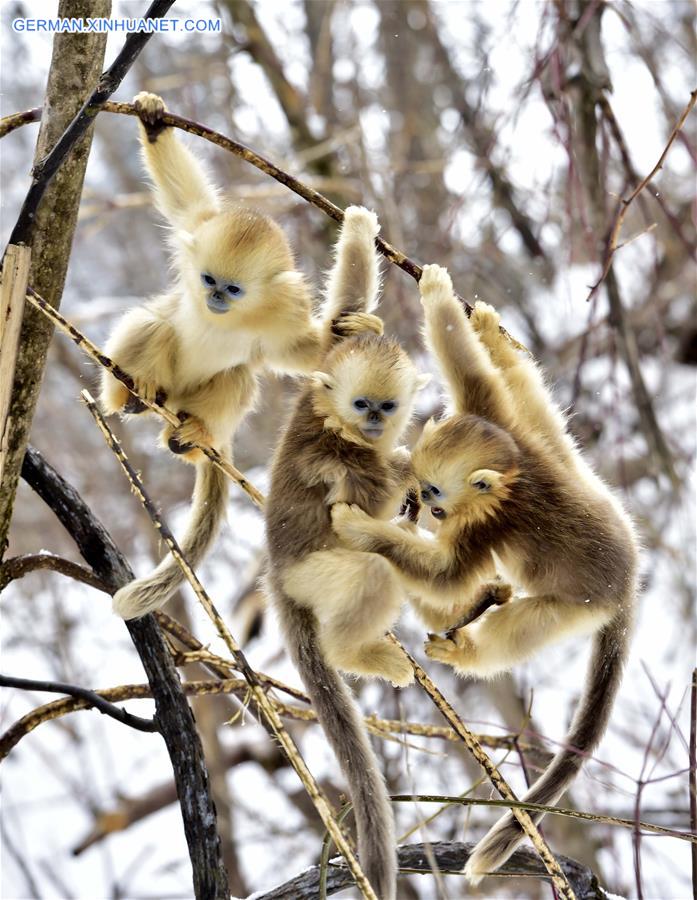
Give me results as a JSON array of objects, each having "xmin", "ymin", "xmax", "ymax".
[{"xmin": 81, "ymin": 391, "xmax": 378, "ymax": 900}]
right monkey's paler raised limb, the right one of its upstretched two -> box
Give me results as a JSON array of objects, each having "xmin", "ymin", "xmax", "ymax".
[{"xmin": 470, "ymin": 302, "xmax": 575, "ymax": 454}]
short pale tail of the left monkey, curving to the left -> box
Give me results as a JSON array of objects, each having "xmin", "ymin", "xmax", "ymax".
[{"xmin": 113, "ymin": 460, "xmax": 228, "ymax": 619}]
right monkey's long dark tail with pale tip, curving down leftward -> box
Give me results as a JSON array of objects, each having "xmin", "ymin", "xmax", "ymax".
[{"xmin": 464, "ymin": 601, "xmax": 633, "ymax": 885}]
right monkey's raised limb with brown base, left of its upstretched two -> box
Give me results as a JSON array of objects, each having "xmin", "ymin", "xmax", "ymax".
[{"xmin": 419, "ymin": 265, "xmax": 515, "ymax": 428}]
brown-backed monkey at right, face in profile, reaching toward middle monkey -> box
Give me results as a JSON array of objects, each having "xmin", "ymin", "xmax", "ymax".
[{"xmin": 333, "ymin": 266, "xmax": 637, "ymax": 883}]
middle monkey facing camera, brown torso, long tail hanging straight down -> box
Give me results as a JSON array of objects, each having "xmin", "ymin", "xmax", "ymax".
[{"xmin": 266, "ymin": 206, "xmax": 428, "ymax": 900}]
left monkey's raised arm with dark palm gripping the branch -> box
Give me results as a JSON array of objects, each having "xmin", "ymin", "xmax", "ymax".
[{"xmin": 133, "ymin": 91, "xmax": 219, "ymax": 231}]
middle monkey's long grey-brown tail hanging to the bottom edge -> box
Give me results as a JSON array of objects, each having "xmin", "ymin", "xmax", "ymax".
[{"xmin": 270, "ymin": 589, "xmax": 397, "ymax": 900}]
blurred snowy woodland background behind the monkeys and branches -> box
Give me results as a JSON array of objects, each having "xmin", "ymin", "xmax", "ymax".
[{"xmin": 1, "ymin": 0, "xmax": 697, "ymax": 898}]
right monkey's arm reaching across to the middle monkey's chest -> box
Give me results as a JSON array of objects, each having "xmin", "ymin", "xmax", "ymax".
[{"xmin": 331, "ymin": 503, "xmax": 491, "ymax": 605}]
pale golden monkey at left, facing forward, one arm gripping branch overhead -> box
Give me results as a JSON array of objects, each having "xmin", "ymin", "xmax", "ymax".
[{"xmin": 101, "ymin": 93, "xmax": 382, "ymax": 619}]
